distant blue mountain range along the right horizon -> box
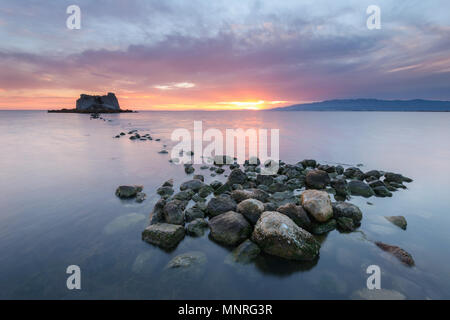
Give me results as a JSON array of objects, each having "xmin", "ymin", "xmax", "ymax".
[{"xmin": 270, "ymin": 99, "xmax": 450, "ymax": 112}]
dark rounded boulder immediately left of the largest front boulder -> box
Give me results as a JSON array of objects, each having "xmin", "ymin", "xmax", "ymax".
[{"xmin": 209, "ymin": 211, "xmax": 252, "ymax": 246}]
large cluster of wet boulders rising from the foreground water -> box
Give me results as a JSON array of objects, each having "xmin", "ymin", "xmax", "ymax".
[{"xmin": 139, "ymin": 159, "xmax": 414, "ymax": 265}]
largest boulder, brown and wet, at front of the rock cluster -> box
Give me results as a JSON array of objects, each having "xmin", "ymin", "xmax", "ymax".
[{"xmin": 252, "ymin": 211, "xmax": 320, "ymax": 260}]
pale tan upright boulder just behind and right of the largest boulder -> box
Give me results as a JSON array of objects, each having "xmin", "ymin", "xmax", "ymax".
[{"xmin": 301, "ymin": 190, "xmax": 333, "ymax": 222}]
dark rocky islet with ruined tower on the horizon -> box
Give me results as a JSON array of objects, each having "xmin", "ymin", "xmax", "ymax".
[{"xmin": 48, "ymin": 92, "xmax": 133, "ymax": 113}]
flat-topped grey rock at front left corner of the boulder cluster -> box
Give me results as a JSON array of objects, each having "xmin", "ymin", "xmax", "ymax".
[{"xmin": 142, "ymin": 223, "xmax": 185, "ymax": 249}]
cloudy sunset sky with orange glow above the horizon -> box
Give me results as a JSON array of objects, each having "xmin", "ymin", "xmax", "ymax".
[{"xmin": 0, "ymin": 0, "xmax": 450, "ymax": 110}]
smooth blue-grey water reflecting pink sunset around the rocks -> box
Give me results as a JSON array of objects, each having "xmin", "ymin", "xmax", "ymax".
[{"xmin": 0, "ymin": 111, "xmax": 450, "ymax": 299}]
